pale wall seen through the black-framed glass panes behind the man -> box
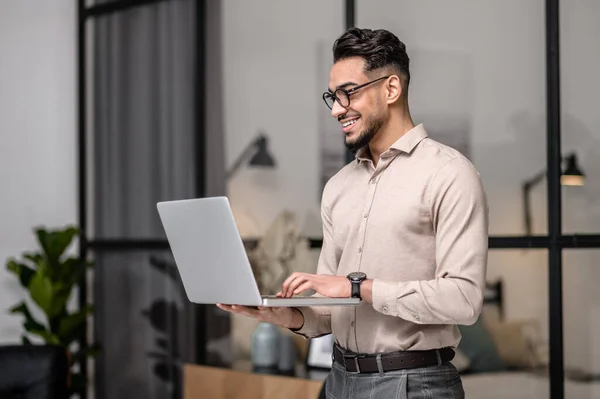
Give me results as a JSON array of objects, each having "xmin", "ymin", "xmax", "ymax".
[{"xmin": 223, "ymin": 0, "xmax": 600, "ymax": 378}]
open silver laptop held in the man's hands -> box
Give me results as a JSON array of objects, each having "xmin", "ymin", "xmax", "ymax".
[{"xmin": 157, "ymin": 197, "xmax": 360, "ymax": 307}]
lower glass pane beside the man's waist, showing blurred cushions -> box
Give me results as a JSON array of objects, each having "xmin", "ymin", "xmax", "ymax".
[{"xmin": 458, "ymin": 250, "xmax": 550, "ymax": 399}]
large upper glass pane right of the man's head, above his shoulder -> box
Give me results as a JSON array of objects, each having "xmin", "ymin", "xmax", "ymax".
[{"xmin": 356, "ymin": 0, "xmax": 547, "ymax": 235}]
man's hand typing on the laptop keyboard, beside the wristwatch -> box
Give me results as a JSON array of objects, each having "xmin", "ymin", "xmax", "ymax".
[{"xmin": 277, "ymin": 272, "xmax": 352, "ymax": 298}]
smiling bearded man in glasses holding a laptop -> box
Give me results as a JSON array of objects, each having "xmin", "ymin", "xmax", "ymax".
[{"xmin": 219, "ymin": 28, "xmax": 488, "ymax": 399}]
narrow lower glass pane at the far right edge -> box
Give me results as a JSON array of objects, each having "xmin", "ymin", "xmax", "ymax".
[{"xmin": 563, "ymin": 249, "xmax": 600, "ymax": 399}]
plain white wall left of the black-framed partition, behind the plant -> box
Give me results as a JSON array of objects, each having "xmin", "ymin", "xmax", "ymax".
[{"xmin": 0, "ymin": 0, "xmax": 77, "ymax": 343}]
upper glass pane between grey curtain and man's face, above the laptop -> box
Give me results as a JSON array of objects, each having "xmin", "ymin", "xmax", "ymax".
[{"xmin": 222, "ymin": 0, "xmax": 345, "ymax": 238}]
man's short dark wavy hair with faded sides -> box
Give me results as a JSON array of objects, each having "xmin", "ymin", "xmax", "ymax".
[{"xmin": 333, "ymin": 28, "xmax": 410, "ymax": 90}]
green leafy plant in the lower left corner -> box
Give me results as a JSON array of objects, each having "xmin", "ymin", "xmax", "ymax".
[{"xmin": 6, "ymin": 226, "xmax": 98, "ymax": 393}]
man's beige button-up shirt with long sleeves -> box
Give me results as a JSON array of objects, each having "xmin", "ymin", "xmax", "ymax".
[{"xmin": 296, "ymin": 125, "xmax": 488, "ymax": 353}]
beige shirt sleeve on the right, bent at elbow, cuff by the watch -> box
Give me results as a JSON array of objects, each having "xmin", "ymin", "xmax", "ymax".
[{"xmin": 373, "ymin": 157, "xmax": 488, "ymax": 325}]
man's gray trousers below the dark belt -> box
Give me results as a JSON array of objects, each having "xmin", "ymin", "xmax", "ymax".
[{"xmin": 325, "ymin": 362, "xmax": 465, "ymax": 399}]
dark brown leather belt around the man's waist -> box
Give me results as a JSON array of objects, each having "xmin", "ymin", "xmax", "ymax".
[{"xmin": 333, "ymin": 344, "xmax": 454, "ymax": 373}]
